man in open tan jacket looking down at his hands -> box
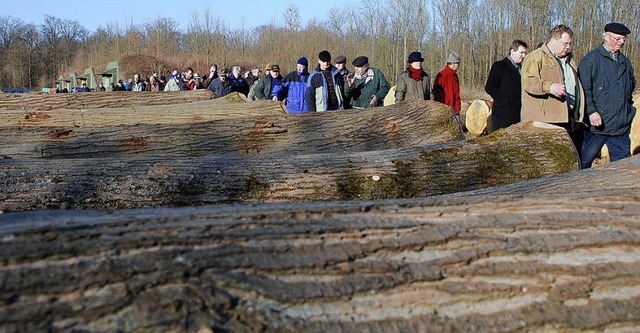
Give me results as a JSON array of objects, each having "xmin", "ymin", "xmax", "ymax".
[{"xmin": 520, "ymin": 24, "xmax": 584, "ymax": 147}]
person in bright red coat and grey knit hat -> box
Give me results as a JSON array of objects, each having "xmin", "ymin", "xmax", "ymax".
[{"xmin": 433, "ymin": 52, "xmax": 462, "ymax": 123}]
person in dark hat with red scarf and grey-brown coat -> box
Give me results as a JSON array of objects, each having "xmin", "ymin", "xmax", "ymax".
[{"xmin": 395, "ymin": 51, "xmax": 431, "ymax": 102}]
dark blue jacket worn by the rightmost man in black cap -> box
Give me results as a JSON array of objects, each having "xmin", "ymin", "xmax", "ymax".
[{"xmin": 578, "ymin": 45, "xmax": 636, "ymax": 136}]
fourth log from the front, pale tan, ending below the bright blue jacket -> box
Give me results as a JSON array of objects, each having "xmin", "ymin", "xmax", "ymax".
[{"xmin": 0, "ymin": 93, "xmax": 284, "ymax": 128}]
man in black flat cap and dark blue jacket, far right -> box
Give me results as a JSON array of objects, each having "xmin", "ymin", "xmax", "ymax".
[{"xmin": 578, "ymin": 23, "xmax": 636, "ymax": 168}]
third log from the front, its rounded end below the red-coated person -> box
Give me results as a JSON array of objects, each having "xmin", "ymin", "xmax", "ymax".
[{"xmin": 0, "ymin": 101, "xmax": 462, "ymax": 159}]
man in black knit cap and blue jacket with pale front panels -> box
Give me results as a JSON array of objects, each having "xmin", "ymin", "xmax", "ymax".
[{"xmin": 306, "ymin": 50, "xmax": 344, "ymax": 112}]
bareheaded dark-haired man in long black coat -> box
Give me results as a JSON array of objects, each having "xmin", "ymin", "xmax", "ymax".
[{"xmin": 484, "ymin": 39, "xmax": 527, "ymax": 133}]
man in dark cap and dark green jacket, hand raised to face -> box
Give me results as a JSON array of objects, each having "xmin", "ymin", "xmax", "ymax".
[{"xmin": 344, "ymin": 56, "xmax": 391, "ymax": 109}]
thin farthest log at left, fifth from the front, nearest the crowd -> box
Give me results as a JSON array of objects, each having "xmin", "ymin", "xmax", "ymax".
[{"xmin": 0, "ymin": 89, "xmax": 215, "ymax": 110}]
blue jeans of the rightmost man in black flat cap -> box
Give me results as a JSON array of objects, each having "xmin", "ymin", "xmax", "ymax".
[{"xmin": 582, "ymin": 131, "xmax": 631, "ymax": 169}]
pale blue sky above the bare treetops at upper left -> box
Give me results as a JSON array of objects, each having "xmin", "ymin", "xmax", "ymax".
[{"xmin": 0, "ymin": 0, "xmax": 350, "ymax": 32}]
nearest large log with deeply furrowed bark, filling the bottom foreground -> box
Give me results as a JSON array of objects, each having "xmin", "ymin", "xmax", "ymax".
[{"xmin": 0, "ymin": 154, "xmax": 640, "ymax": 333}]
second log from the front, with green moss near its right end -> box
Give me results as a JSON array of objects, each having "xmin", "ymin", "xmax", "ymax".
[{"xmin": 0, "ymin": 120, "xmax": 579, "ymax": 211}]
